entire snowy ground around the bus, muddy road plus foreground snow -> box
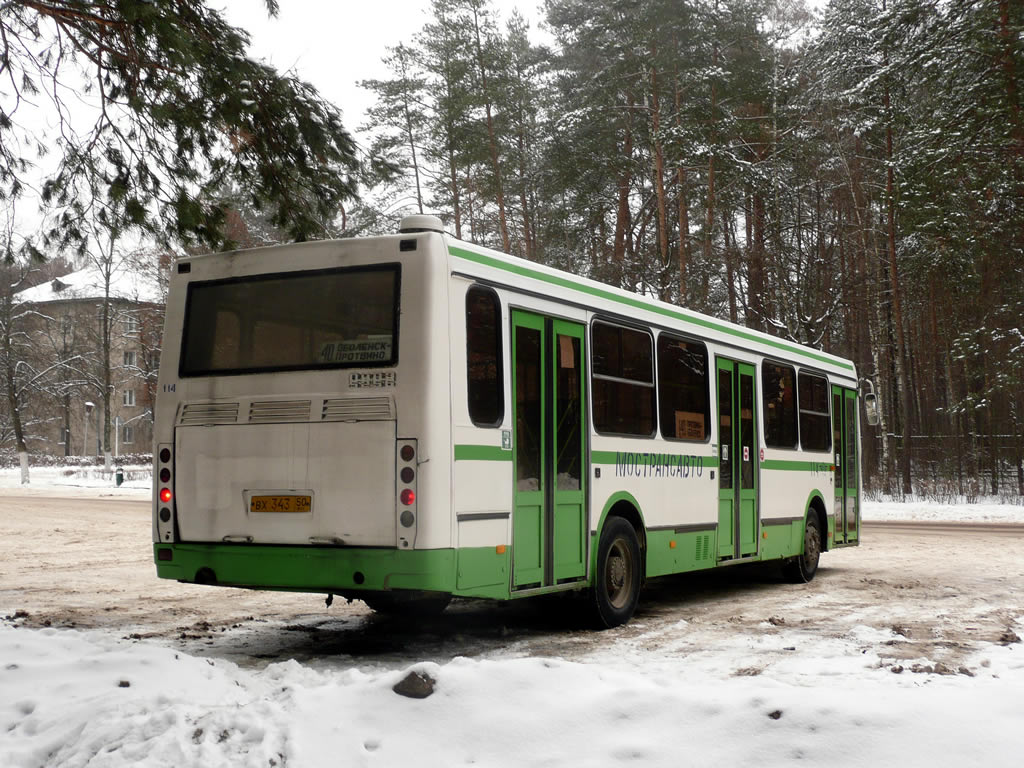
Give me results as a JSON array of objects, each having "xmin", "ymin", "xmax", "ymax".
[{"xmin": 0, "ymin": 493, "xmax": 1024, "ymax": 768}]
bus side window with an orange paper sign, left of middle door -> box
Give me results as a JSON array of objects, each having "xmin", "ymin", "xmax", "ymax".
[{"xmin": 657, "ymin": 334, "xmax": 710, "ymax": 442}]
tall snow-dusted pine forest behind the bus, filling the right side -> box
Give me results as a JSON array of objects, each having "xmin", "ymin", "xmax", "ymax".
[{"xmin": 348, "ymin": 0, "xmax": 1024, "ymax": 498}]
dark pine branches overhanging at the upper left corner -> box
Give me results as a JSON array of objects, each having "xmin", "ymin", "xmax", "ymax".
[{"xmin": 0, "ymin": 0, "xmax": 357, "ymax": 248}]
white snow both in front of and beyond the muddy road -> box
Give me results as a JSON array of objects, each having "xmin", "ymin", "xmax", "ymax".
[{"xmin": 0, "ymin": 469, "xmax": 1024, "ymax": 768}]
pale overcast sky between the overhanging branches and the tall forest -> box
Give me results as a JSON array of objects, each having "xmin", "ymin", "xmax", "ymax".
[{"xmin": 219, "ymin": 0, "xmax": 544, "ymax": 145}]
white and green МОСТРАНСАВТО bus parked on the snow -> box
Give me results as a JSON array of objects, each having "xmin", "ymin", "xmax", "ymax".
[{"xmin": 153, "ymin": 216, "xmax": 873, "ymax": 627}]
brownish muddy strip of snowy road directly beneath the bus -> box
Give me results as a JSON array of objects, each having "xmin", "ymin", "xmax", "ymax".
[{"xmin": 0, "ymin": 495, "xmax": 1024, "ymax": 673}]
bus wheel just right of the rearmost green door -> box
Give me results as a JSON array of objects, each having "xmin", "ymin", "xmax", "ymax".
[{"xmin": 591, "ymin": 517, "xmax": 641, "ymax": 629}]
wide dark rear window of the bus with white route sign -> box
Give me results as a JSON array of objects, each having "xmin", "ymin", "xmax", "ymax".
[{"xmin": 179, "ymin": 264, "xmax": 399, "ymax": 377}]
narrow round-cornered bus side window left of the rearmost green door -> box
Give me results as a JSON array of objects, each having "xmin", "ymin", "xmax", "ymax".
[{"xmin": 466, "ymin": 286, "xmax": 505, "ymax": 427}]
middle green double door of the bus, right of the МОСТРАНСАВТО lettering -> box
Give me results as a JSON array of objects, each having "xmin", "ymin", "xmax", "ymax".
[{"xmin": 717, "ymin": 357, "xmax": 758, "ymax": 560}]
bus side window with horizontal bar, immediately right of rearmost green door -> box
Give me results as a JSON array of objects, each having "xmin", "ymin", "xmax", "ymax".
[{"xmin": 591, "ymin": 323, "xmax": 654, "ymax": 437}]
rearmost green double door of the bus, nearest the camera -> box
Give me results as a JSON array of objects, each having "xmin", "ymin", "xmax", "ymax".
[{"xmin": 512, "ymin": 310, "xmax": 587, "ymax": 590}]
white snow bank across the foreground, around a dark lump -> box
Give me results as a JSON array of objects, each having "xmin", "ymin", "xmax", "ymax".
[{"xmin": 0, "ymin": 621, "xmax": 1024, "ymax": 768}]
